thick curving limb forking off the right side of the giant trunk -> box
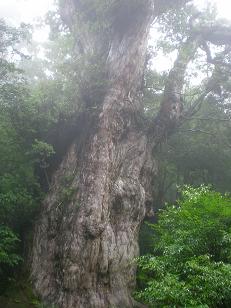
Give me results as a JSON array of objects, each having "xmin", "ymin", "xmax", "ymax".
[{"xmin": 150, "ymin": 25, "xmax": 231, "ymax": 146}]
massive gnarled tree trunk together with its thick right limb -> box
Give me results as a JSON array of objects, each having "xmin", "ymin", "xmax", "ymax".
[{"xmin": 32, "ymin": 0, "xmax": 230, "ymax": 308}]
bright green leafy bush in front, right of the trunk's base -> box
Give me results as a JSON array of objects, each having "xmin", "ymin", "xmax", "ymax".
[{"xmin": 135, "ymin": 186, "xmax": 231, "ymax": 307}]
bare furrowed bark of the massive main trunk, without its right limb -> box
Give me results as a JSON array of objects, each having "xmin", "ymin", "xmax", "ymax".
[{"xmin": 32, "ymin": 1, "xmax": 154, "ymax": 308}]
